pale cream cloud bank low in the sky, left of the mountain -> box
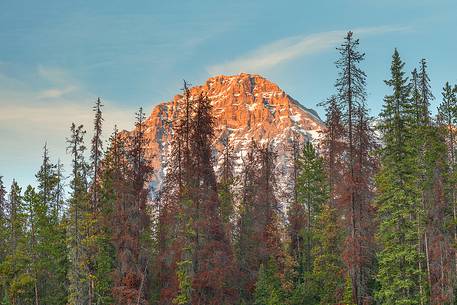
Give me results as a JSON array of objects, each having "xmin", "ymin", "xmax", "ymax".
[{"xmin": 0, "ymin": 66, "xmax": 135, "ymax": 132}]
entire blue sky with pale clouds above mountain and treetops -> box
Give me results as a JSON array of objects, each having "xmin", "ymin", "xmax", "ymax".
[{"xmin": 0, "ymin": 0, "xmax": 457, "ymax": 186}]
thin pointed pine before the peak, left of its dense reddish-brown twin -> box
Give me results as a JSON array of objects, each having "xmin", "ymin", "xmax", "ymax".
[{"xmin": 157, "ymin": 82, "xmax": 193, "ymax": 304}]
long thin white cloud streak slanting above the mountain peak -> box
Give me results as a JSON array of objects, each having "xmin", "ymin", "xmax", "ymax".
[{"xmin": 207, "ymin": 26, "xmax": 410, "ymax": 75}]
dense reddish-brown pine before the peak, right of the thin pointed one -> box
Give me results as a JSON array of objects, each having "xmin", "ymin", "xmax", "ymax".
[{"xmin": 191, "ymin": 96, "xmax": 236, "ymax": 304}]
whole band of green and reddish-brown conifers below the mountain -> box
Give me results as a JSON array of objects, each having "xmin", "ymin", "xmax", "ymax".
[{"xmin": 0, "ymin": 32, "xmax": 457, "ymax": 305}]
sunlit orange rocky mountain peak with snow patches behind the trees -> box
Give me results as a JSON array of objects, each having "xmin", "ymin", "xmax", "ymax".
[{"xmin": 141, "ymin": 73, "xmax": 323, "ymax": 189}]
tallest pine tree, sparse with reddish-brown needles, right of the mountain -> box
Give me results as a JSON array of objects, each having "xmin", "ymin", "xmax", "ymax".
[{"xmin": 335, "ymin": 32, "xmax": 373, "ymax": 304}]
